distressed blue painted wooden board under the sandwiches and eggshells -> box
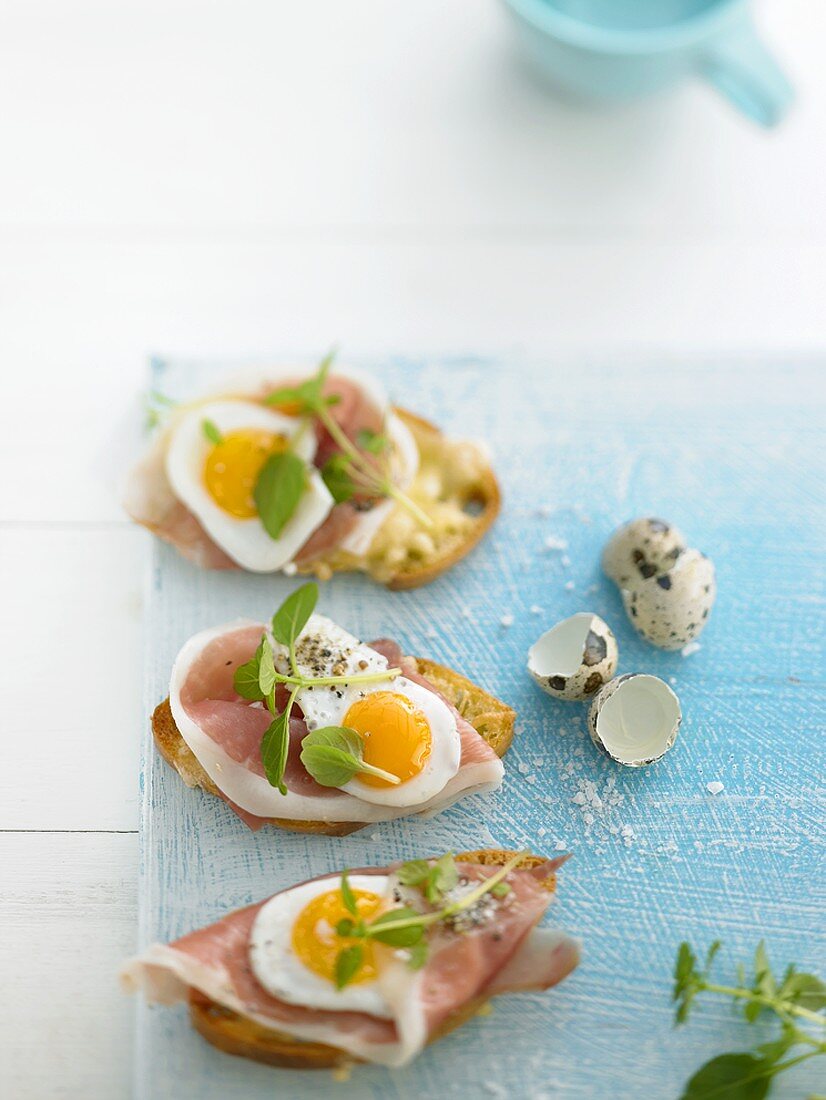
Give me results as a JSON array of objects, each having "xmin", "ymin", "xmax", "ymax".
[{"xmin": 135, "ymin": 355, "xmax": 826, "ymax": 1100}]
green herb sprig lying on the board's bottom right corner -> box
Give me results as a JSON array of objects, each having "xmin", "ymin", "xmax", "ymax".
[{"xmin": 672, "ymin": 939, "xmax": 826, "ymax": 1100}]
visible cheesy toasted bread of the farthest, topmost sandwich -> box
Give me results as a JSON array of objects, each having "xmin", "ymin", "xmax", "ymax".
[{"xmin": 299, "ymin": 408, "xmax": 502, "ymax": 590}]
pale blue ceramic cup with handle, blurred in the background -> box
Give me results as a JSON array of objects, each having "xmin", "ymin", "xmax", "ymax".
[{"xmin": 504, "ymin": 0, "xmax": 793, "ymax": 127}]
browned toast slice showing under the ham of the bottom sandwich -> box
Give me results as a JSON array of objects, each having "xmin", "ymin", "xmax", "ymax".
[{"xmin": 189, "ymin": 848, "xmax": 557, "ymax": 1069}]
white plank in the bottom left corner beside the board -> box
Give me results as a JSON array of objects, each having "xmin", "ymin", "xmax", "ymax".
[{"xmin": 0, "ymin": 833, "xmax": 137, "ymax": 1100}]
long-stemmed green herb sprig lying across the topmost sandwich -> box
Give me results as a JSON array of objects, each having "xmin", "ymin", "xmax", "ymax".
[{"xmin": 265, "ymin": 351, "xmax": 433, "ymax": 528}]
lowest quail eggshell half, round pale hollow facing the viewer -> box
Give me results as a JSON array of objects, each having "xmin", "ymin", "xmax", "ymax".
[{"xmin": 588, "ymin": 672, "xmax": 682, "ymax": 768}]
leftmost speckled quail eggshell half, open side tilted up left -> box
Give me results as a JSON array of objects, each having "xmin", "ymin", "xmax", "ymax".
[{"xmin": 528, "ymin": 612, "xmax": 618, "ymax": 700}]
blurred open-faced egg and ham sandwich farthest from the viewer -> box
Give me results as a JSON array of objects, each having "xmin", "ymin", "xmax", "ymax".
[{"xmin": 124, "ymin": 356, "xmax": 499, "ymax": 589}]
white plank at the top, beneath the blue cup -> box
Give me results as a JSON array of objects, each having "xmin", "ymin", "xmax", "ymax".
[{"xmin": 0, "ymin": 0, "xmax": 826, "ymax": 236}]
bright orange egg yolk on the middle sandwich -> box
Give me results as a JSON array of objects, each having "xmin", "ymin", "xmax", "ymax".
[{"xmin": 343, "ymin": 691, "xmax": 431, "ymax": 787}]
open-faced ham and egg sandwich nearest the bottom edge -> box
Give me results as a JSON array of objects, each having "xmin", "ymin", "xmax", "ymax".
[{"xmin": 122, "ymin": 850, "xmax": 579, "ymax": 1068}]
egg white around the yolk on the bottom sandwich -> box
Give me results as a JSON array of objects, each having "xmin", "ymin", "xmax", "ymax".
[{"xmin": 250, "ymin": 875, "xmax": 394, "ymax": 1019}]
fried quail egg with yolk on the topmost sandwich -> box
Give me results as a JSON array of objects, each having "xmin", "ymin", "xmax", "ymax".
[{"xmin": 166, "ymin": 400, "xmax": 333, "ymax": 573}]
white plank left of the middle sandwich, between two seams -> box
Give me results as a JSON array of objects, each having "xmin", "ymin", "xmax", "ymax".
[{"xmin": 0, "ymin": 526, "xmax": 148, "ymax": 829}]
